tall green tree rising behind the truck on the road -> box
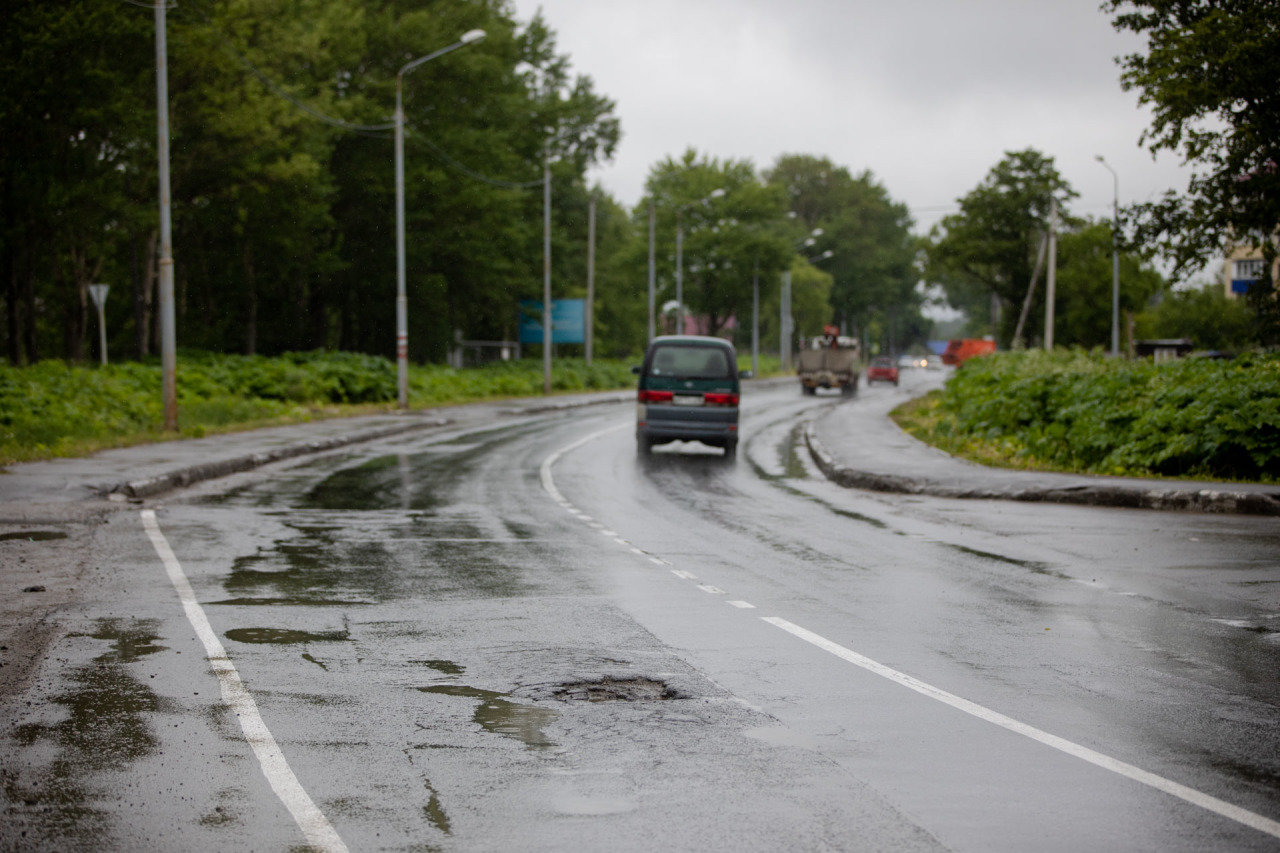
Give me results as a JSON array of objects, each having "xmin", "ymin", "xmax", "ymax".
[{"xmin": 765, "ymin": 155, "xmax": 928, "ymax": 348}]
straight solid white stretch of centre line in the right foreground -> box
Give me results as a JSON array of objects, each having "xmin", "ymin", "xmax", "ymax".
[{"xmin": 762, "ymin": 616, "xmax": 1280, "ymax": 838}]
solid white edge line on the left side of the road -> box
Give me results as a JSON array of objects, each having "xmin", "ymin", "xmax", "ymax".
[{"xmin": 142, "ymin": 510, "xmax": 347, "ymax": 853}]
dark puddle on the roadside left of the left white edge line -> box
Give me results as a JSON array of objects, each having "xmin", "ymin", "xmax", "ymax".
[{"xmin": 3, "ymin": 619, "xmax": 173, "ymax": 849}]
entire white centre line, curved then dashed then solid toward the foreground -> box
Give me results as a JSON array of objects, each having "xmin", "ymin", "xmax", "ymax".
[{"xmin": 540, "ymin": 424, "xmax": 1280, "ymax": 838}]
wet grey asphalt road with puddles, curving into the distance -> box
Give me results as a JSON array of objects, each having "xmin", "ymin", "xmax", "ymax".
[{"xmin": 0, "ymin": 386, "xmax": 1280, "ymax": 850}]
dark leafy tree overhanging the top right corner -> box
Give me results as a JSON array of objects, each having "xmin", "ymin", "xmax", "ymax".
[{"xmin": 1103, "ymin": 0, "xmax": 1280, "ymax": 345}]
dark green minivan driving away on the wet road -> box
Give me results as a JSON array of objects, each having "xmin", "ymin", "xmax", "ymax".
[{"xmin": 631, "ymin": 336, "xmax": 751, "ymax": 459}]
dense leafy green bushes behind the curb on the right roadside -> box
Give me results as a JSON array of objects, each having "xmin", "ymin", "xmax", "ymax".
[{"xmin": 933, "ymin": 351, "xmax": 1280, "ymax": 480}]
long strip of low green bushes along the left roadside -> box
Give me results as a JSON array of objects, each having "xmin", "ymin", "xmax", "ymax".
[{"xmin": 0, "ymin": 350, "xmax": 634, "ymax": 464}]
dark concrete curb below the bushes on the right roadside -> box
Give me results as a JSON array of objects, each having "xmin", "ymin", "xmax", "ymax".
[{"xmin": 804, "ymin": 420, "xmax": 1280, "ymax": 516}]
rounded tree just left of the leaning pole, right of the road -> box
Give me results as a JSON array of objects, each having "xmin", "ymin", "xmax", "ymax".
[{"xmin": 925, "ymin": 149, "xmax": 1076, "ymax": 345}]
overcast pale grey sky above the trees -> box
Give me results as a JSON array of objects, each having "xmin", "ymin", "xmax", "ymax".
[{"xmin": 515, "ymin": 0, "xmax": 1187, "ymax": 239}]
